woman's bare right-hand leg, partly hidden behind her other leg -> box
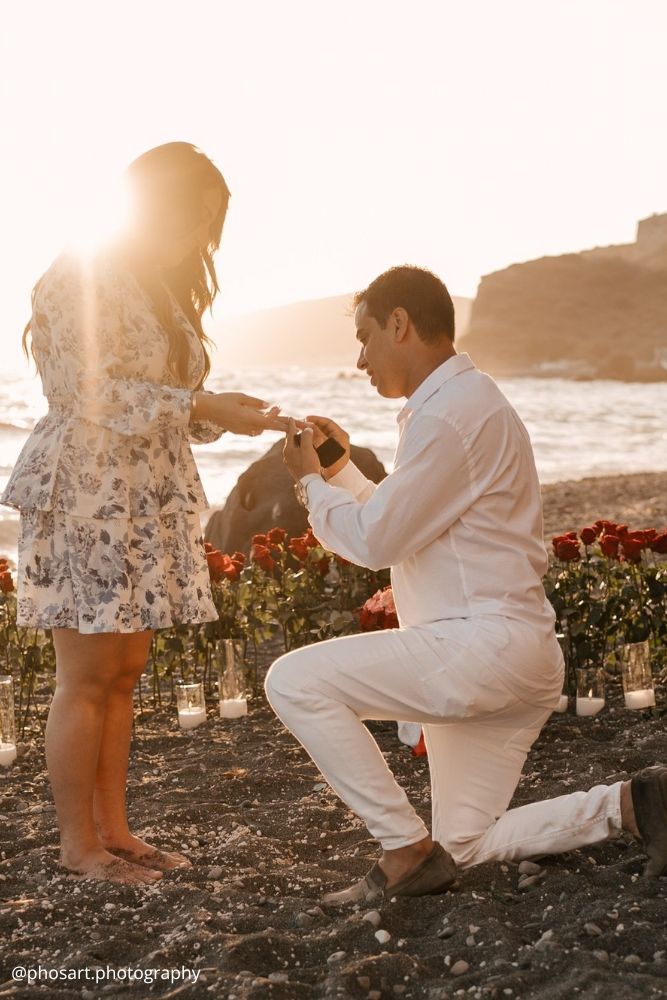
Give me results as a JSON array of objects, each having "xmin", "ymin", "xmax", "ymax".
[{"xmin": 93, "ymin": 631, "xmax": 189, "ymax": 870}]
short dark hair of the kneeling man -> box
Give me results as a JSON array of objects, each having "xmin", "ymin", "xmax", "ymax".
[{"xmin": 354, "ymin": 264, "xmax": 455, "ymax": 344}]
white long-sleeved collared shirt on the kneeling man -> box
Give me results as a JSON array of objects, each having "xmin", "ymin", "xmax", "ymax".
[{"xmin": 301, "ymin": 354, "xmax": 554, "ymax": 629}]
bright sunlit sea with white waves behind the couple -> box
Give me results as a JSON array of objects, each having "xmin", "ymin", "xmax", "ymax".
[{"xmin": 0, "ymin": 365, "xmax": 667, "ymax": 557}]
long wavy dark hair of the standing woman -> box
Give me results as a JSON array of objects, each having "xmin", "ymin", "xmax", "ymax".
[{"xmin": 23, "ymin": 142, "xmax": 230, "ymax": 386}]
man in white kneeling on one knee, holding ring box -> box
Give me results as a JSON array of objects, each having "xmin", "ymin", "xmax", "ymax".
[{"xmin": 266, "ymin": 267, "xmax": 667, "ymax": 903}]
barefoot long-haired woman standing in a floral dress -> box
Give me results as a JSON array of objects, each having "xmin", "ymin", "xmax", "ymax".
[{"xmin": 2, "ymin": 142, "xmax": 285, "ymax": 883}]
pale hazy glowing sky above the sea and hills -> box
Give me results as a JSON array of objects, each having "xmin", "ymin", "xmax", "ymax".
[{"xmin": 0, "ymin": 0, "xmax": 667, "ymax": 372}]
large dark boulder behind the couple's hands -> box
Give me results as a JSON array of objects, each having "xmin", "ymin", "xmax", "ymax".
[{"xmin": 206, "ymin": 441, "xmax": 387, "ymax": 553}]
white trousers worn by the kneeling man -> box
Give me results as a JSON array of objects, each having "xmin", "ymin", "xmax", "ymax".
[{"xmin": 266, "ymin": 615, "xmax": 622, "ymax": 868}]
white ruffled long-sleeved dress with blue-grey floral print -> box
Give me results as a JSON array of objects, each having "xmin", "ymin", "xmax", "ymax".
[{"xmin": 0, "ymin": 251, "xmax": 222, "ymax": 633}]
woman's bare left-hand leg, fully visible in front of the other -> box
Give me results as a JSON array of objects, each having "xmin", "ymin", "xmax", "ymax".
[{"xmin": 46, "ymin": 629, "xmax": 160, "ymax": 882}]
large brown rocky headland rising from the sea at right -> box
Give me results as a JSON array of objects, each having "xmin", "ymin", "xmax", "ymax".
[{"xmin": 464, "ymin": 215, "xmax": 667, "ymax": 381}]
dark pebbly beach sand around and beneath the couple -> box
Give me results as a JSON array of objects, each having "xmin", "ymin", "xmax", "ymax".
[{"xmin": 0, "ymin": 473, "xmax": 667, "ymax": 1000}]
